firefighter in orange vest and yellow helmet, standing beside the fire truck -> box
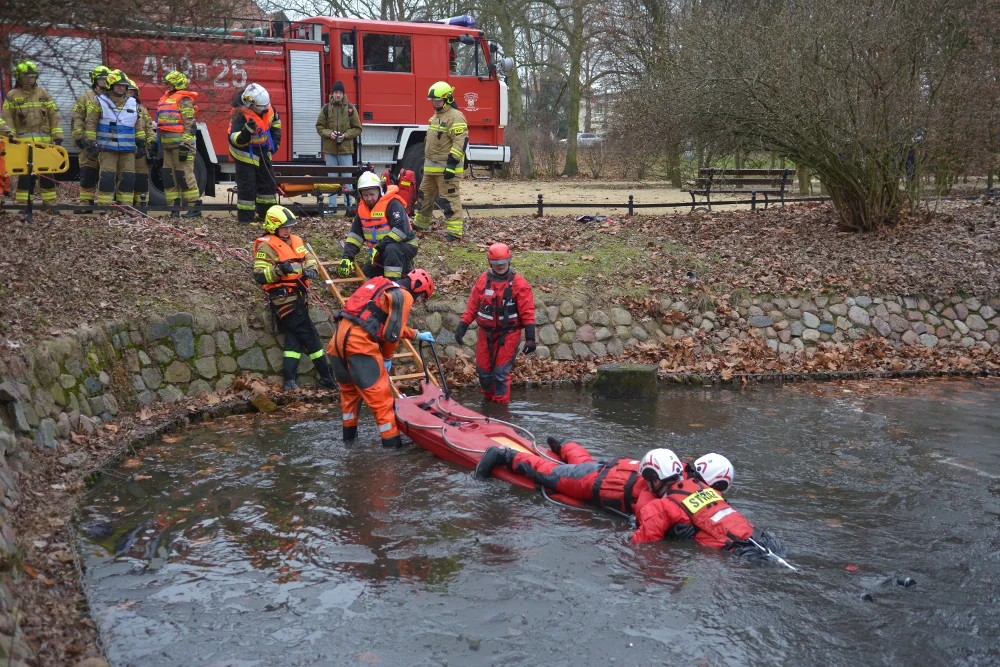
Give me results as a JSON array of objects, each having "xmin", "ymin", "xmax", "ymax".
[{"xmin": 156, "ymin": 70, "xmax": 201, "ymax": 218}]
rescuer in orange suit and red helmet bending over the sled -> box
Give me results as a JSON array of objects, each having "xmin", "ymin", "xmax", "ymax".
[{"xmin": 326, "ymin": 269, "xmax": 434, "ymax": 447}]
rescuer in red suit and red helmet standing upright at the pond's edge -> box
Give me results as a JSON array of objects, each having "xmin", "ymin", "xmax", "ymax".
[{"xmin": 455, "ymin": 243, "xmax": 536, "ymax": 403}]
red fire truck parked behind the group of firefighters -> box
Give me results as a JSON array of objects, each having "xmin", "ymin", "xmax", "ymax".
[{"xmin": 0, "ymin": 17, "xmax": 513, "ymax": 204}]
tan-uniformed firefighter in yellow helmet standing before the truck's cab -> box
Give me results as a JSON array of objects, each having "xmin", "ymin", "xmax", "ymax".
[{"xmin": 413, "ymin": 81, "xmax": 469, "ymax": 241}]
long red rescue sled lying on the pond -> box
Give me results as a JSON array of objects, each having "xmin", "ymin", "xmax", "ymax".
[{"xmin": 396, "ymin": 380, "xmax": 584, "ymax": 507}]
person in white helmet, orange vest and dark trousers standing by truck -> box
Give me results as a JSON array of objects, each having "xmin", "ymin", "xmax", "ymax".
[{"xmin": 229, "ymin": 83, "xmax": 281, "ymax": 224}]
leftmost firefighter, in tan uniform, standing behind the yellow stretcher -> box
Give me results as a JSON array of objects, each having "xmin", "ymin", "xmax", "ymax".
[{"xmin": 2, "ymin": 60, "xmax": 63, "ymax": 207}]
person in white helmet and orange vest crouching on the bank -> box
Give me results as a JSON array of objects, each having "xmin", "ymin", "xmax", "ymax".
[{"xmin": 337, "ymin": 171, "xmax": 419, "ymax": 280}]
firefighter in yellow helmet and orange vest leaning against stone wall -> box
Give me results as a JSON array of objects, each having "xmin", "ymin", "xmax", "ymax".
[{"xmin": 253, "ymin": 206, "xmax": 334, "ymax": 391}]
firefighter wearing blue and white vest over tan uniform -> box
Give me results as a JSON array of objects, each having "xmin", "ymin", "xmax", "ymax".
[{"xmin": 84, "ymin": 69, "xmax": 139, "ymax": 206}]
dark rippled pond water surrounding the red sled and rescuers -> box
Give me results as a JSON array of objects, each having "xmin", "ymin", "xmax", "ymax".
[{"xmin": 79, "ymin": 381, "xmax": 1000, "ymax": 666}]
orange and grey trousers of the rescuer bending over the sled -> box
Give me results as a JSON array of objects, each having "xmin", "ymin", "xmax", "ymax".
[{"xmin": 326, "ymin": 320, "xmax": 403, "ymax": 447}]
